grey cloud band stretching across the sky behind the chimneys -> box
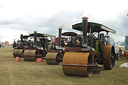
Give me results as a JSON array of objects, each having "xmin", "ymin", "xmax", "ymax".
[{"xmin": 0, "ymin": 10, "xmax": 128, "ymax": 42}]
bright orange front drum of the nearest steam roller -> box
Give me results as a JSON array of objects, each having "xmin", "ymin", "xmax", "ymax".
[{"xmin": 62, "ymin": 52, "xmax": 93, "ymax": 77}]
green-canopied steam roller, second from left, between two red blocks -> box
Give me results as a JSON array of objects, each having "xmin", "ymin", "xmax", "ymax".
[{"xmin": 23, "ymin": 31, "xmax": 55, "ymax": 61}]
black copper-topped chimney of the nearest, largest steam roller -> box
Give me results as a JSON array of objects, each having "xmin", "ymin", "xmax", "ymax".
[{"xmin": 82, "ymin": 17, "xmax": 88, "ymax": 44}]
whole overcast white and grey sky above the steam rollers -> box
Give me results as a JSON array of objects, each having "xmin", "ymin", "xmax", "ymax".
[{"xmin": 0, "ymin": 0, "xmax": 128, "ymax": 42}]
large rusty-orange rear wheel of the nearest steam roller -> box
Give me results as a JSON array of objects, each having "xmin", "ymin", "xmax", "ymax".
[{"xmin": 103, "ymin": 45, "xmax": 115, "ymax": 70}]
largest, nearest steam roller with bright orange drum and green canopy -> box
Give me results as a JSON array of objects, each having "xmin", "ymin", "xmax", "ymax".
[{"xmin": 62, "ymin": 17, "xmax": 115, "ymax": 77}]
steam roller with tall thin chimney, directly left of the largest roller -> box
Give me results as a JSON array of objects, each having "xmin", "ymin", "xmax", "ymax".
[{"xmin": 45, "ymin": 28, "xmax": 77, "ymax": 65}]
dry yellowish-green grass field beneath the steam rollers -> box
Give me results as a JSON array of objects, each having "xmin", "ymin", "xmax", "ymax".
[{"xmin": 0, "ymin": 47, "xmax": 128, "ymax": 85}]
